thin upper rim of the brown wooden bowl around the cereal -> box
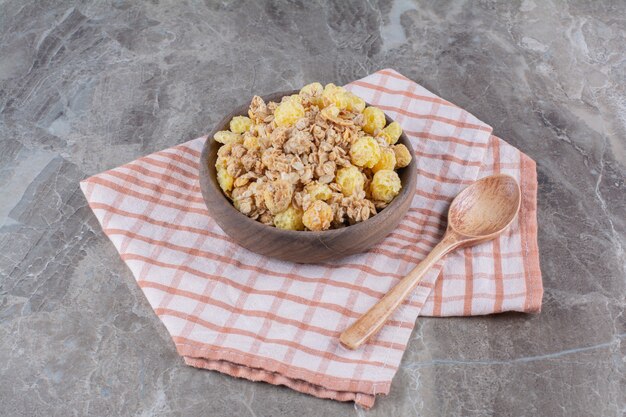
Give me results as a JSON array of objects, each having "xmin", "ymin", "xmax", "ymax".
[{"xmin": 199, "ymin": 90, "xmax": 417, "ymax": 237}]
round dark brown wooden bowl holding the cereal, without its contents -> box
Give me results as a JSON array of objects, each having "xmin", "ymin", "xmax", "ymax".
[{"xmin": 200, "ymin": 91, "xmax": 417, "ymax": 263}]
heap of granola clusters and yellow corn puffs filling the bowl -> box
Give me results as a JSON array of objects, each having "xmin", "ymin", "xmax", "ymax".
[{"xmin": 214, "ymin": 83, "xmax": 411, "ymax": 231}]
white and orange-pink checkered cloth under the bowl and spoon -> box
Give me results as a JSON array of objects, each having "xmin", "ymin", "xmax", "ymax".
[{"xmin": 81, "ymin": 70, "xmax": 543, "ymax": 407}]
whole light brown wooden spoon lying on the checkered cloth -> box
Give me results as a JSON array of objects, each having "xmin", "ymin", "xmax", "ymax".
[{"xmin": 339, "ymin": 174, "xmax": 521, "ymax": 349}]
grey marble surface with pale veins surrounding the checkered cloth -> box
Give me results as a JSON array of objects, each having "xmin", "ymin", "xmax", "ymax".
[{"xmin": 0, "ymin": 0, "xmax": 626, "ymax": 417}]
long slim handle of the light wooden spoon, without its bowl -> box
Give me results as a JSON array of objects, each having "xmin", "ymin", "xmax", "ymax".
[{"xmin": 339, "ymin": 233, "xmax": 458, "ymax": 350}]
